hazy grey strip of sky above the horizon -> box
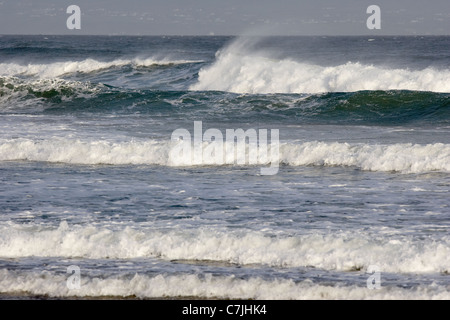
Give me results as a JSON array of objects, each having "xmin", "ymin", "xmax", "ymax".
[{"xmin": 0, "ymin": 0, "xmax": 450, "ymax": 35}]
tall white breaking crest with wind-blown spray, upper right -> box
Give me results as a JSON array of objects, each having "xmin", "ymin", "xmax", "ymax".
[{"xmin": 190, "ymin": 40, "xmax": 450, "ymax": 93}]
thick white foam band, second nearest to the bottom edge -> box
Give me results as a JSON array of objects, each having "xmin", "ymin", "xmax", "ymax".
[{"xmin": 0, "ymin": 222, "xmax": 450, "ymax": 273}]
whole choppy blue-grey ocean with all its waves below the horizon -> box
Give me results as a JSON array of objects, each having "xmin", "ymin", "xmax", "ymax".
[{"xmin": 0, "ymin": 35, "xmax": 450, "ymax": 300}]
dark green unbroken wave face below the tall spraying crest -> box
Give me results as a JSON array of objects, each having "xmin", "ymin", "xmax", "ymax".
[{"xmin": 0, "ymin": 79, "xmax": 450, "ymax": 125}]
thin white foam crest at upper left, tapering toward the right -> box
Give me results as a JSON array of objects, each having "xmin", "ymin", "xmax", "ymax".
[{"xmin": 0, "ymin": 58, "xmax": 198, "ymax": 79}]
